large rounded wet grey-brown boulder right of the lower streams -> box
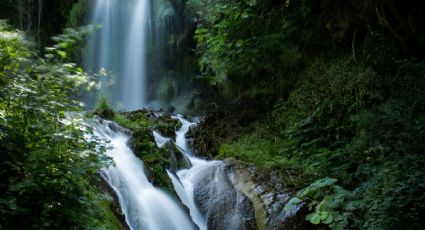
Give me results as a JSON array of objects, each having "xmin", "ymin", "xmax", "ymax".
[{"xmin": 189, "ymin": 159, "xmax": 309, "ymax": 230}]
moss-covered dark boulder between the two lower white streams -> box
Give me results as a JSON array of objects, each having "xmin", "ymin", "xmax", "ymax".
[{"xmin": 108, "ymin": 106, "xmax": 186, "ymax": 194}]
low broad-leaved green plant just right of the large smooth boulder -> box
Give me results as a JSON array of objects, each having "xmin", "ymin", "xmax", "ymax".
[{"xmin": 285, "ymin": 177, "xmax": 355, "ymax": 230}]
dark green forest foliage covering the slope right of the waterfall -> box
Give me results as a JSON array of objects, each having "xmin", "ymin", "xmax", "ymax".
[{"xmin": 189, "ymin": 0, "xmax": 425, "ymax": 229}]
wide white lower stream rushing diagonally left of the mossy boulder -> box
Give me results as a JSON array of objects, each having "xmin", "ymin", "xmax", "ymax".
[{"xmin": 95, "ymin": 121, "xmax": 194, "ymax": 230}]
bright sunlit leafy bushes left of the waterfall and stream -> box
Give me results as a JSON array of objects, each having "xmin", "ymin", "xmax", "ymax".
[{"xmin": 0, "ymin": 21, "xmax": 119, "ymax": 229}]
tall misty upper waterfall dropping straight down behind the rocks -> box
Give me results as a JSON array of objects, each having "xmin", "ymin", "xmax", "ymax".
[{"xmin": 84, "ymin": 0, "xmax": 193, "ymax": 112}]
